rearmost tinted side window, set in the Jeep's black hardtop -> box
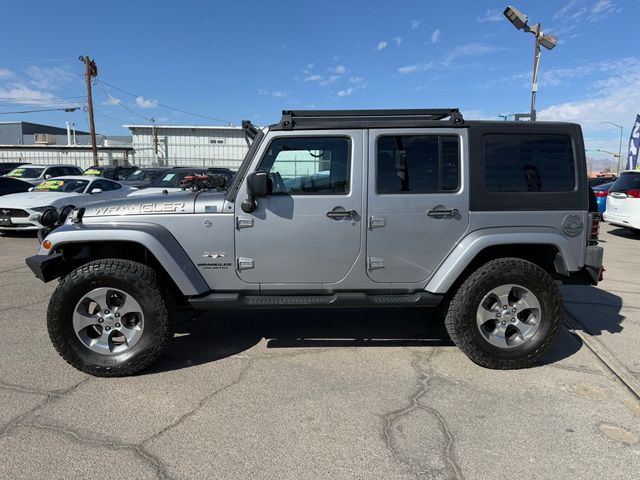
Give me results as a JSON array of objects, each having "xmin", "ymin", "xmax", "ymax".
[{"xmin": 484, "ymin": 134, "xmax": 576, "ymax": 192}]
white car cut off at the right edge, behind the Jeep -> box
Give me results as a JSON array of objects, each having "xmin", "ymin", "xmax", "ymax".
[{"xmin": 604, "ymin": 170, "xmax": 640, "ymax": 230}]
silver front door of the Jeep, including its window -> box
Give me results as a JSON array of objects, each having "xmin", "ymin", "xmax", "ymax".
[{"xmin": 236, "ymin": 130, "xmax": 364, "ymax": 288}]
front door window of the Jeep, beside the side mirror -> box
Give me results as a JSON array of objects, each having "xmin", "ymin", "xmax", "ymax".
[{"xmin": 258, "ymin": 137, "xmax": 351, "ymax": 195}]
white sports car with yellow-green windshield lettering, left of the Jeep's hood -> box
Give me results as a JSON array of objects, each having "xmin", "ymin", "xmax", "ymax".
[{"xmin": 0, "ymin": 175, "xmax": 135, "ymax": 232}]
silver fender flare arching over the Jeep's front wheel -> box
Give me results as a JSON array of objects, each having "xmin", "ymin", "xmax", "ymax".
[{"xmin": 38, "ymin": 223, "xmax": 210, "ymax": 295}]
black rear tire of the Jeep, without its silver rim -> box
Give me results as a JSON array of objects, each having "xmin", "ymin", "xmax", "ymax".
[{"xmin": 445, "ymin": 258, "xmax": 564, "ymax": 370}]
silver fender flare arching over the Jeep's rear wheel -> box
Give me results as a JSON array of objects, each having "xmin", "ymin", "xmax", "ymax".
[{"xmin": 425, "ymin": 227, "xmax": 580, "ymax": 294}]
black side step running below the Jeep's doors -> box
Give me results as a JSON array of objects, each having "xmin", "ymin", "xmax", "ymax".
[{"xmin": 189, "ymin": 292, "xmax": 443, "ymax": 310}]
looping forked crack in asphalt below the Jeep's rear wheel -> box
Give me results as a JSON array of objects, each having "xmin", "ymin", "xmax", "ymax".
[{"xmin": 383, "ymin": 350, "xmax": 464, "ymax": 480}]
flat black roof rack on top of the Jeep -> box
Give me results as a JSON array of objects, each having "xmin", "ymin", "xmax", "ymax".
[{"xmin": 272, "ymin": 108, "xmax": 464, "ymax": 130}]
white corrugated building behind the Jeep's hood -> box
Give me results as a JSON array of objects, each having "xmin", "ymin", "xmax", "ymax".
[{"xmin": 124, "ymin": 125, "xmax": 248, "ymax": 170}]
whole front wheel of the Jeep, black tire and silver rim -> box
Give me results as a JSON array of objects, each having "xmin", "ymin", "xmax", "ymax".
[{"xmin": 47, "ymin": 259, "xmax": 173, "ymax": 376}]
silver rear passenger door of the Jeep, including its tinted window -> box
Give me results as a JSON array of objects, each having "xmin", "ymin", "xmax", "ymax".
[{"xmin": 367, "ymin": 129, "xmax": 469, "ymax": 284}]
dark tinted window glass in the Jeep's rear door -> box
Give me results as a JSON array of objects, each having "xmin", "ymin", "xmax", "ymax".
[{"xmin": 377, "ymin": 135, "xmax": 460, "ymax": 194}]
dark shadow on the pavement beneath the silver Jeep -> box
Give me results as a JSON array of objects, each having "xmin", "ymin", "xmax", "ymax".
[{"xmin": 148, "ymin": 308, "xmax": 582, "ymax": 374}]
